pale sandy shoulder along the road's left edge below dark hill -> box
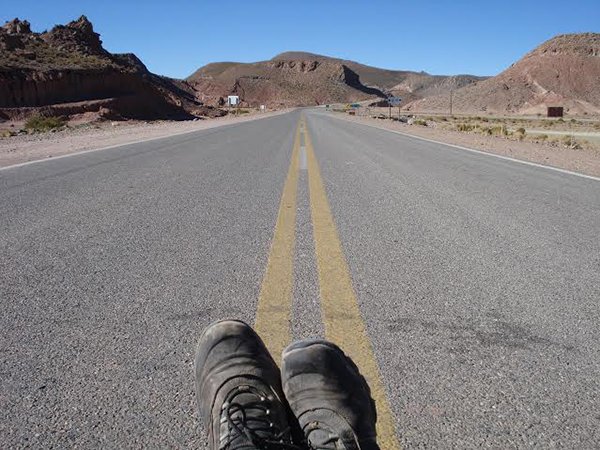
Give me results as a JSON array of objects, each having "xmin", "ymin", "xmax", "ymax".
[{"xmin": 0, "ymin": 110, "xmax": 289, "ymax": 167}]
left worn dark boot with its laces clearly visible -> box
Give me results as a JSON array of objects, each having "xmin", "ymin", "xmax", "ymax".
[{"xmin": 195, "ymin": 320, "xmax": 298, "ymax": 450}]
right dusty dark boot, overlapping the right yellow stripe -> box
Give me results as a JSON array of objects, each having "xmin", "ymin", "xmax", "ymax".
[{"xmin": 281, "ymin": 340, "xmax": 379, "ymax": 450}]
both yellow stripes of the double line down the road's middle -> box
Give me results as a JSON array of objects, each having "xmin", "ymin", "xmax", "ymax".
[{"xmin": 255, "ymin": 119, "xmax": 400, "ymax": 450}]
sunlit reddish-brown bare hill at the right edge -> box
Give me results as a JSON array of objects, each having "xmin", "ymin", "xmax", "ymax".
[{"xmin": 409, "ymin": 33, "xmax": 600, "ymax": 114}]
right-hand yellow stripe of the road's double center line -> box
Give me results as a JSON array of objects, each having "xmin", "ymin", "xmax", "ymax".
[{"xmin": 304, "ymin": 118, "xmax": 400, "ymax": 450}]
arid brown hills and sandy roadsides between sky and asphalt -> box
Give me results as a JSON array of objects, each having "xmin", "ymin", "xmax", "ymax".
[{"xmin": 0, "ymin": 16, "xmax": 600, "ymax": 173}]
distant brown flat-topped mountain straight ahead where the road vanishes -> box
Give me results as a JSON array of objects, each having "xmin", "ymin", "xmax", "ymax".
[{"xmin": 187, "ymin": 52, "xmax": 479, "ymax": 106}]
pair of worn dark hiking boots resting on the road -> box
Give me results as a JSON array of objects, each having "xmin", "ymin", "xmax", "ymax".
[{"xmin": 195, "ymin": 320, "xmax": 379, "ymax": 450}]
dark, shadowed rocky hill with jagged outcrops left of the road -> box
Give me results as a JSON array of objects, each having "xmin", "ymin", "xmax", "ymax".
[{"xmin": 0, "ymin": 16, "xmax": 223, "ymax": 119}]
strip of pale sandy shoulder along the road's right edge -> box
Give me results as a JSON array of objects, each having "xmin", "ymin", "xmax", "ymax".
[{"xmin": 332, "ymin": 113, "xmax": 600, "ymax": 176}]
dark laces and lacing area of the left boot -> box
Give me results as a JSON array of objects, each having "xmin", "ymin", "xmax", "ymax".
[{"xmin": 219, "ymin": 386, "xmax": 301, "ymax": 450}]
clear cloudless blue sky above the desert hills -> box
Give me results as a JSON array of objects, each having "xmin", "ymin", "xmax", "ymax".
[{"xmin": 0, "ymin": 0, "xmax": 600, "ymax": 78}]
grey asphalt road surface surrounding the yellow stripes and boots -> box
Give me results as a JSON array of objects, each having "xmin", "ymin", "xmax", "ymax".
[{"xmin": 0, "ymin": 110, "xmax": 600, "ymax": 449}]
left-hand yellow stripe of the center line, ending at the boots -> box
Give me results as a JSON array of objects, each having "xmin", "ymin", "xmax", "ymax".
[{"xmin": 254, "ymin": 122, "xmax": 301, "ymax": 360}]
